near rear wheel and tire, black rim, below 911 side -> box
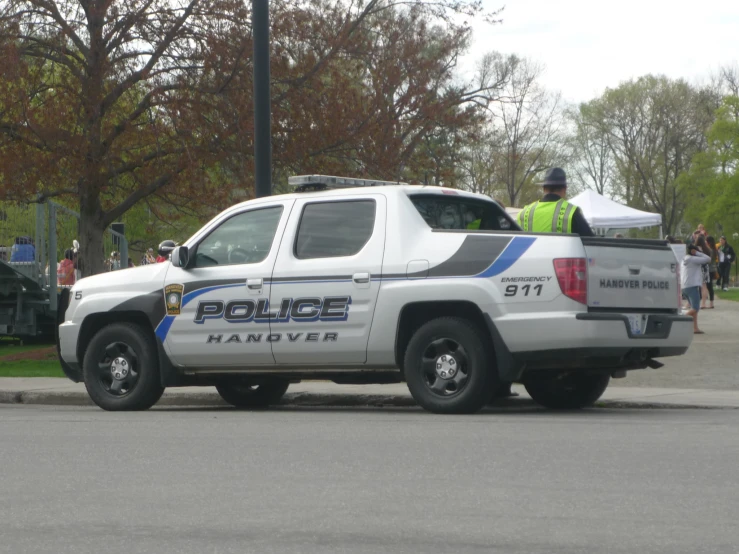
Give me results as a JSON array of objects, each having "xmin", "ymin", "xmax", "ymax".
[{"xmin": 403, "ymin": 317, "xmax": 497, "ymax": 414}]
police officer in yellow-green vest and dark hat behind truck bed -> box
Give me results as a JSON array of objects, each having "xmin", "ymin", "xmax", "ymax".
[{"xmin": 518, "ymin": 167, "xmax": 595, "ymax": 237}]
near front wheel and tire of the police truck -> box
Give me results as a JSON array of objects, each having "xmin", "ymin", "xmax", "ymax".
[{"xmin": 82, "ymin": 323, "xmax": 164, "ymax": 411}]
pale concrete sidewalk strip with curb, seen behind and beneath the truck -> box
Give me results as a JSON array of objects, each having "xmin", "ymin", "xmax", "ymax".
[{"xmin": 0, "ymin": 377, "xmax": 739, "ymax": 409}]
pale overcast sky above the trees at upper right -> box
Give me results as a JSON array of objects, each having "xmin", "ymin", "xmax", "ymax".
[{"xmin": 463, "ymin": 0, "xmax": 739, "ymax": 102}]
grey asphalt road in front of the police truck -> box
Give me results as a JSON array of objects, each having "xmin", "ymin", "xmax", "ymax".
[{"xmin": 0, "ymin": 406, "xmax": 739, "ymax": 554}]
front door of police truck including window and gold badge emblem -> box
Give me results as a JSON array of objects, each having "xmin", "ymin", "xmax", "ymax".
[{"xmin": 164, "ymin": 200, "xmax": 294, "ymax": 368}]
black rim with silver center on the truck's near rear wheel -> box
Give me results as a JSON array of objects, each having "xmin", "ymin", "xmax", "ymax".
[{"xmin": 421, "ymin": 338, "xmax": 470, "ymax": 398}]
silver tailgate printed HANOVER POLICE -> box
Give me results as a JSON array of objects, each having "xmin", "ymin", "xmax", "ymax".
[{"xmin": 582, "ymin": 237, "xmax": 679, "ymax": 311}]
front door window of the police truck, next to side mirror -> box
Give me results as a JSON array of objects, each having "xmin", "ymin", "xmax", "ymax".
[{"xmin": 195, "ymin": 206, "xmax": 282, "ymax": 267}]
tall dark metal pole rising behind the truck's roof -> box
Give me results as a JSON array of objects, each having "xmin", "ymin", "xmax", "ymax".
[{"xmin": 251, "ymin": 0, "xmax": 272, "ymax": 198}]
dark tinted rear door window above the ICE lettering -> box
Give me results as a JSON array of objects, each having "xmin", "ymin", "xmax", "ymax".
[{"xmin": 295, "ymin": 200, "xmax": 375, "ymax": 260}]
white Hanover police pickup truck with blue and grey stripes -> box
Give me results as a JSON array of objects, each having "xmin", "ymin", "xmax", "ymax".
[{"xmin": 58, "ymin": 175, "xmax": 693, "ymax": 413}]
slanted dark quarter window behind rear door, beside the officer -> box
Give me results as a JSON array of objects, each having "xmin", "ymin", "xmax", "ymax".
[{"xmin": 408, "ymin": 194, "xmax": 521, "ymax": 231}]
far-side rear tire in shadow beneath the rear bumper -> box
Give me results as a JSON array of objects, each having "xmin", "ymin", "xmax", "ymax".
[{"xmin": 524, "ymin": 373, "xmax": 611, "ymax": 410}]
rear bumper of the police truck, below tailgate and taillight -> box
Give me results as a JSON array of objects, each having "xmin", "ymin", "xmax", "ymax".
[{"xmin": 495, "ymin": 312, "xmax": 693, "ymax": 378}]
